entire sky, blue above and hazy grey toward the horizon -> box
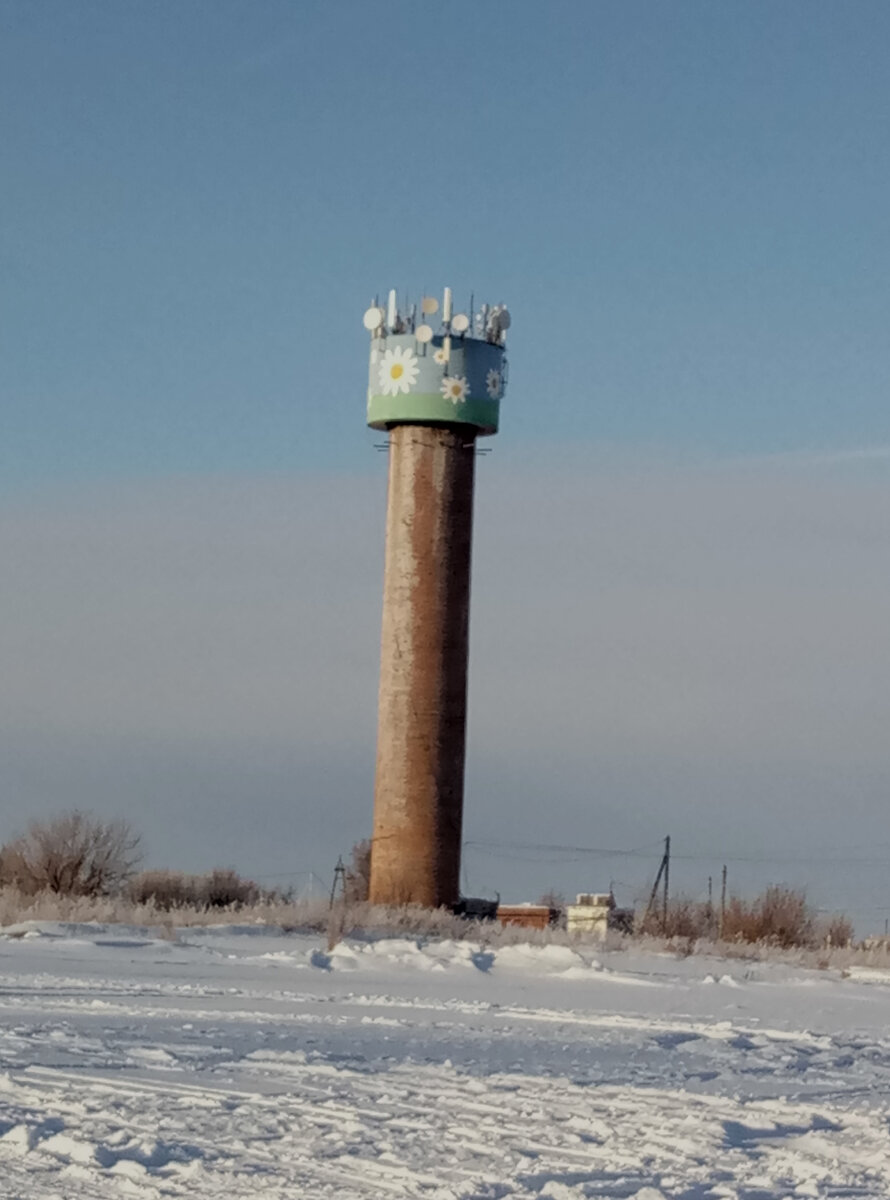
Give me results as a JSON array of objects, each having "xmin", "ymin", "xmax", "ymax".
[{"xmin": 0, "ymin": 0, "xmax": 890, "ymax": 929}]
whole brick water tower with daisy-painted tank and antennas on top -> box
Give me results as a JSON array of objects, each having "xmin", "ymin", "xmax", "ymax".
[{"xmin": 365, "ymin": 288, "xmax": 510, "ymax": 907}]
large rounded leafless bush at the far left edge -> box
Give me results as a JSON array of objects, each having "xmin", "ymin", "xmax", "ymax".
[{"xmin": 0, "ymin": 809, "xmax": 140, "ymax": 896}]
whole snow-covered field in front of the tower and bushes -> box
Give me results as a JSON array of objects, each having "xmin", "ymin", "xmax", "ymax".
[{"xmin": 0, "ymin": 923, "xmax": 890, "ymax": 1200}]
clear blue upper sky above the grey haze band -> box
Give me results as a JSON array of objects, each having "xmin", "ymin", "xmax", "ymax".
[{"xmin": 6, "ymin": 0, "xmax": 890, "ymax": 488}]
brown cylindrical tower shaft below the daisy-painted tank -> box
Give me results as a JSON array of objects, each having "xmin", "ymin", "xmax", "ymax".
[{"xmin": 371, "ymin": 425, "xmax": 476, "ymax": 907}]
